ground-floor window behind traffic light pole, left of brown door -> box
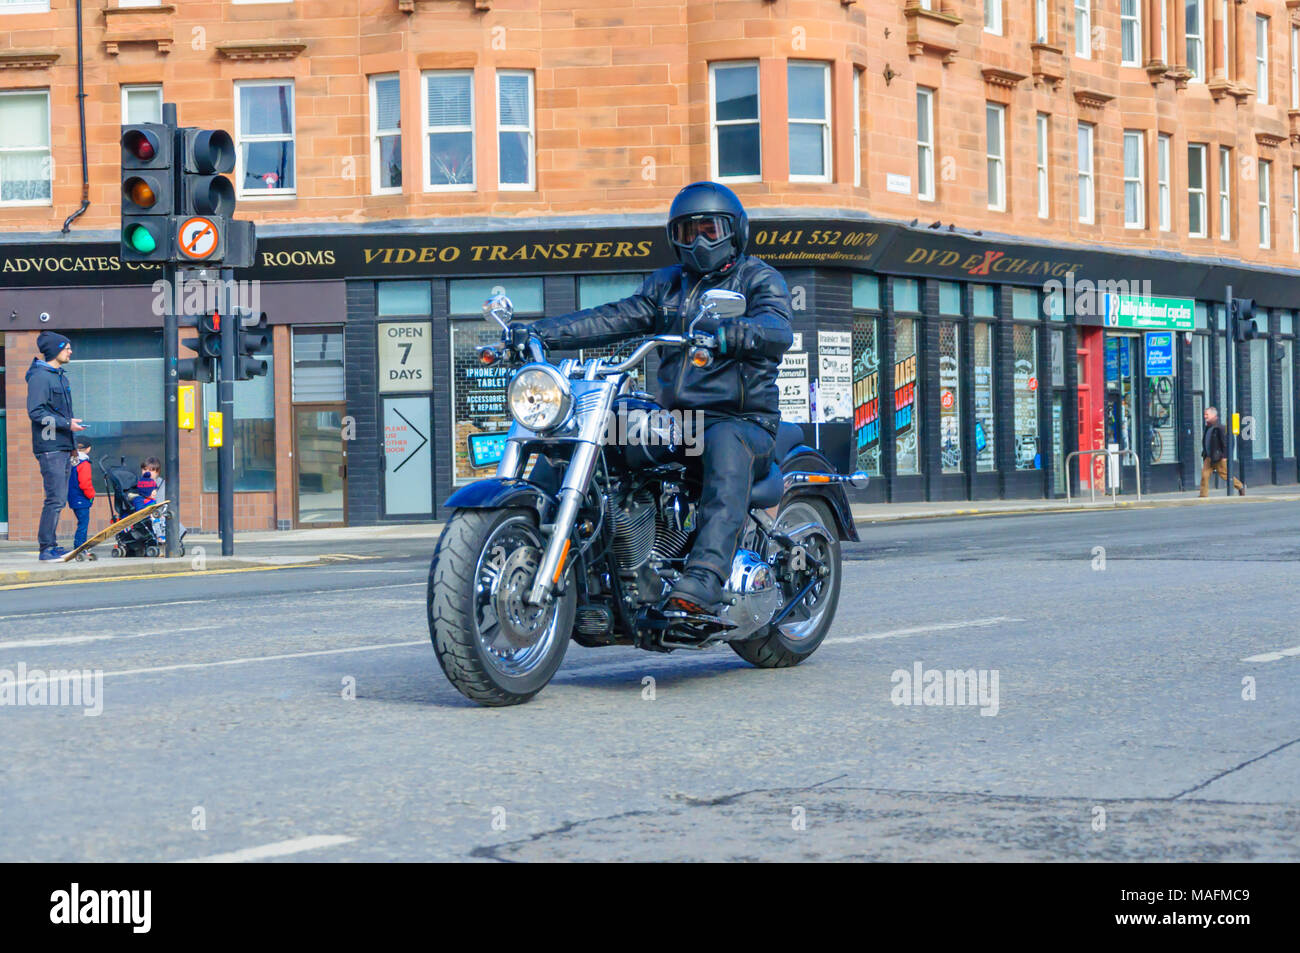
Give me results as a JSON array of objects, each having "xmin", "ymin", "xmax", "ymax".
[{"xmin": 203, "ymin": 350, "xmax": 276, "ymax": 493}]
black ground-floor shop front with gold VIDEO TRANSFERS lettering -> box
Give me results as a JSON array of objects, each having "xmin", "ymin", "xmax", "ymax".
[{"xmin": 0, "ymin": 216, "xmax": 1300, "ymax": 528}]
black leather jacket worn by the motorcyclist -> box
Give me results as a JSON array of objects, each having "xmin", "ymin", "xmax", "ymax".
[{"xmin": 529, "ymin": 255, "xmax": 794, "ymax": 433}]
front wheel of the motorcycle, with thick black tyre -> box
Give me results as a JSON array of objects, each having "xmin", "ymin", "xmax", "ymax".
[{"xmin": 428, "ymin": 510, "xmax": 576, "ymax": 707}]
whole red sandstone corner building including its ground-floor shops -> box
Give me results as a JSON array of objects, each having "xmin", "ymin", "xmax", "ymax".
[{"xmin": 0, "ymin": 0, "xmax": 1300, "ymax": 538}]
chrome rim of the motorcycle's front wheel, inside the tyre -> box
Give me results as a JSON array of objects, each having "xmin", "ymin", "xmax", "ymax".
[{"xmin": 475, "ymin": 516, "xmax": 559, "ymax": 679}]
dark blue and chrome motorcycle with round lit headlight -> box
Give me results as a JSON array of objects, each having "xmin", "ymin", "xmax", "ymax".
[{"xmin": 428, "ymin": 290, "xmax": 867, "ymax": 706}]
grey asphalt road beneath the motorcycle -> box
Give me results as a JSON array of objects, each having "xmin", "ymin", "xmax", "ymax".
[{"xmin": 0, "ymin": 501, "xmax": 1300, "ymax": 861}]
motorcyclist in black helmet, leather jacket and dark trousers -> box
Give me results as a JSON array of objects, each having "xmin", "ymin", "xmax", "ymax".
[{"xmin": 511, "ymin": 182, "xmax": 793, "ymax": 615}]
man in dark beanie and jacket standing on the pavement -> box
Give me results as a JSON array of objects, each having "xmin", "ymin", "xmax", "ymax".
[{"xmin": 27, "ymin": 332, "xmax": 86, "ymax": 560}]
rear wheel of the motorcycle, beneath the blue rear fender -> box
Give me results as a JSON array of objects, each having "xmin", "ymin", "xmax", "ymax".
[{"xmin": 728, "ymin": 497, "xmax": 842, "ymax": 668}]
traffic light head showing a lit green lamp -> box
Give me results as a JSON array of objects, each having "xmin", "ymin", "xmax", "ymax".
[{"xmin": 121, "ymin": 122, "xmax": 176, "ymax": 261}]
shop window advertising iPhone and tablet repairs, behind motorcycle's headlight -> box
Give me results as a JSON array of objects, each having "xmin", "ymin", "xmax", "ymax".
[{"xmin": 449, "ymin": 278, "xmax": 543, "ymax": 484}]
